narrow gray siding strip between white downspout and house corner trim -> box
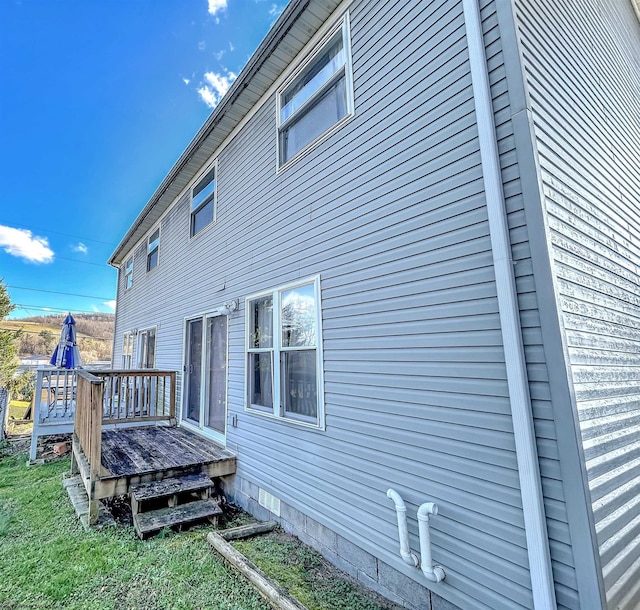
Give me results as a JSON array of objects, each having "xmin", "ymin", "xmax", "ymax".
[{"xmin": 481, "ymin": 0, "xmax": 580, "ymax": 608}]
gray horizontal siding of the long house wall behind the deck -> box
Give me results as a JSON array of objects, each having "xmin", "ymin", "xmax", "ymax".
[{"xmin": 109, "ymin": 0, "xmax": 604, "ymax": 609}]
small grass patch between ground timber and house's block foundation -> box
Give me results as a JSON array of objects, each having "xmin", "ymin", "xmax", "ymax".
[{"xmin": 233, "ymin": 530, "xmax": 396, "ymax": 610}]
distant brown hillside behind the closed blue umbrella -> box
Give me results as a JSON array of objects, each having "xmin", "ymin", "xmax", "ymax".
[{"xmin": 0, "ymin": 313, "xmax": 115, "ymax": 363}]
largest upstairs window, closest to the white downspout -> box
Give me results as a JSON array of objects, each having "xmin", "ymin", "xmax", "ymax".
[{"xmin": 278, "ymin": 16, "xmax": 353, "ymax": 165}]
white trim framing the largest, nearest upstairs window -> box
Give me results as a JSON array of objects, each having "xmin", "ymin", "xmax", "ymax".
[{"xmin": 276, "ymin": 11, "xmax": 355, "ymax": 173}]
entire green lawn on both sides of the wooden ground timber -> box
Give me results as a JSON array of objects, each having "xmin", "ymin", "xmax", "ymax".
[{"xmin": 0, "ymin": 445, "xmax": 398, "ymax": 610}]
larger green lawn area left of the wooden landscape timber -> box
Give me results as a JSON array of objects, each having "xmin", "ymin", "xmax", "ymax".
[{"xmin": 0, "ymin": 448, "xmax": 269, "ymax": 610}]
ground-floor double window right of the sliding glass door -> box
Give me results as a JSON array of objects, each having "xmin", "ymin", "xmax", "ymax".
[{"xmin": 247, "ymin": 278, "xmax": 323, "ymax": 426}]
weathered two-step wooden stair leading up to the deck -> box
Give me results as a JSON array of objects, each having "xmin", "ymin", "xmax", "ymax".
[{"xmin": 131, "ymin": 473, "xmax": 222, "ymax": 538}]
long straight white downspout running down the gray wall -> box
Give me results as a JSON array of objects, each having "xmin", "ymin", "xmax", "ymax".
[{"xmin": 462, "ymin": 0, "xmax": 556, "ymax": 610}]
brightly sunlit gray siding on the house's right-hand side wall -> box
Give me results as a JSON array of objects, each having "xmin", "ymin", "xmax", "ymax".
[{"xmin": 518, "ymin": 0, "xmax": 640, "ymax": 608}]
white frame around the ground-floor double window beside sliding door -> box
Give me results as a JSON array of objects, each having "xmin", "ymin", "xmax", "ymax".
[{"xmin": 244, "ymin": 275, "xmax": 326, "ymax": 430}]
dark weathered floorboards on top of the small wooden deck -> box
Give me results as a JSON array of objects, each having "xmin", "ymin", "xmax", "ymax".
[{"xmin": 102, "ymin": 426, "xmax": 235, "ymax": 477}]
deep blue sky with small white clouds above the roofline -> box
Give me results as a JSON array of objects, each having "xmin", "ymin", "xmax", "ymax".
[{"xmin": 0, "ymin": 0, "xmax": 286, "ymax": 318}]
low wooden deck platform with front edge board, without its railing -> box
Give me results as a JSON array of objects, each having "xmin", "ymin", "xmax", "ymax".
[{"xmin": 76, "ymin": 425, "xmax": 236, "ymax": 500}]
